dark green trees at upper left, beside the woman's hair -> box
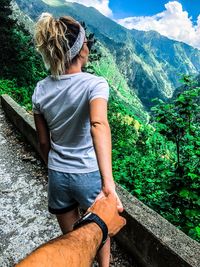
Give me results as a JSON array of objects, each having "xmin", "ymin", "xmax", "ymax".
[{"xmin": 0, "ymin": 0, "xmax": 46, "ymax": 86}]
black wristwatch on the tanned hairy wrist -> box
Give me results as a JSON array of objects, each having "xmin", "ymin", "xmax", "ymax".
[{"xmin": 73, "ymin": 212, "xmax": 108, "ymax": 249}]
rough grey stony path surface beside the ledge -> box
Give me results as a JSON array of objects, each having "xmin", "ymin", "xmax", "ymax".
[{"xmin": 0, "ymin": 107, "xmax": 136, "ymax": 267}]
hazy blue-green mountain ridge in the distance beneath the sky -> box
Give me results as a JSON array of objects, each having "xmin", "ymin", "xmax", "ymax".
[{"xmin": 16, "ymin": 0, "xmax": 200, "ymax": 109}]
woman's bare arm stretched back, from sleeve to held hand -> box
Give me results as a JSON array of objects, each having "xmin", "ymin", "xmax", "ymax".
[{"xmin": 90, "ymin": 98, "xmax": 123, "ymax": 211}]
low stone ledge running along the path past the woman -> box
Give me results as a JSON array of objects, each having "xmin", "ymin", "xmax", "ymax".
[{"xmin": 1, "ymin": 95, "xmax": 200, "ymax": 267}]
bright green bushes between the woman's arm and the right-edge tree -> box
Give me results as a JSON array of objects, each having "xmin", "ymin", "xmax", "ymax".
[{"xmin": 110, "ymin": 112, "xmax": 172, "ymax": 216}]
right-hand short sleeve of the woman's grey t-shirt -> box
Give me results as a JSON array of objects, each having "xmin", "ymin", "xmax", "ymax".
[{"xmin": 89, "ymin": 77, "xmax": 109, "ymax": 102}]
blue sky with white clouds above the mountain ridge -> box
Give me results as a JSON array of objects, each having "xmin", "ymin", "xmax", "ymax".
[{"xmin": 64, "ymin": 0, "xmax": 200, "ymax": 49}]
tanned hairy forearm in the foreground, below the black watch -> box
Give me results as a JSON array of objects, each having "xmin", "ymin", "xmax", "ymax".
[{"xmin": 16, "ymin": 223, "xmax": 102, "ymax": 267}]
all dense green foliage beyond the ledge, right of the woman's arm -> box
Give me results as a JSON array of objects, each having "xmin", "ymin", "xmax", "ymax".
[{"xmin": 109, "ymin": 74, "xmax": 200, "ymax": 241}]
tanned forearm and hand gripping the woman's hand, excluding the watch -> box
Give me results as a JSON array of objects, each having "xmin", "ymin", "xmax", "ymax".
[{"xmin": 16, "ymin": 194, "xmax": 126, "ymax": 267}]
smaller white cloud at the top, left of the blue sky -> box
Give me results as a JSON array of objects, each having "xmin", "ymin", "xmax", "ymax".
[{"xmin": 66, "ymin": 0, "xmax": 113, "ymax": 18}]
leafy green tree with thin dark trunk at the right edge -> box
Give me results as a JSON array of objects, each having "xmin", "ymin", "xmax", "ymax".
[{"xmin": 153, "ymin": 76, "xmax": 200, "ymax": 240}]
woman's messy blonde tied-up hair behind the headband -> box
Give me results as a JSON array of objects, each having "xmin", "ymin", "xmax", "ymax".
[{"xmin": 34, "ymin": 13, "xmax": 80, "ymax": 78}]
